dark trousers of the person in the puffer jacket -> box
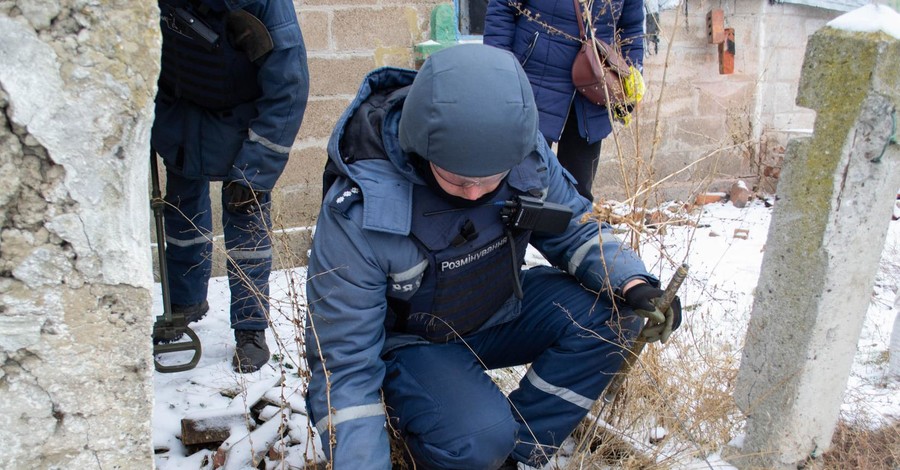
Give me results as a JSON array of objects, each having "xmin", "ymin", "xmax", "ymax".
[{"xmin": 544, "ymin": 106, "xmax": 603, "ymax": 202}]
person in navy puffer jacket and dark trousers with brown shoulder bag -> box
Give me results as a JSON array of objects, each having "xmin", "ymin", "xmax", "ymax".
[{"xmin": 484, "ymin": 0, "xmax": 644, "ymax": 201}]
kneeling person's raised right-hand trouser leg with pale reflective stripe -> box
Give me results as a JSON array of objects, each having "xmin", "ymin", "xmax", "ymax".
[{"xmin": 466, "ymin": 267, "xmax": 641, "ymax": 466}]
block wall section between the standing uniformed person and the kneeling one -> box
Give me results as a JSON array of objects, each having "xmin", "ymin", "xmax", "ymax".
[{"xmin": 268, "ymin": 0, "xmax": 441, "ymax": 267}]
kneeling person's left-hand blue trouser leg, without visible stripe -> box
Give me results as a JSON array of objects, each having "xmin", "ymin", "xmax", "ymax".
[{"xmin": 382, "ymin": 343, "xmax": 519, "ymax": 469}]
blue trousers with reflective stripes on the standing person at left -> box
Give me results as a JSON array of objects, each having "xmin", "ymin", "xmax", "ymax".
[{"xmin": 163, "ymin": 171, "xmax": 272, "ymax": 330}]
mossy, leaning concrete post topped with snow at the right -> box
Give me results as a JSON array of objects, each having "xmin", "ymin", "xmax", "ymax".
[{"xmin": 727, "ymin": 6, "xmax": 900, "ymax": 469}]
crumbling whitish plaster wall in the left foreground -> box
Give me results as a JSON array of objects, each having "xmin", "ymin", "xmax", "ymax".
[{"xmin": 0, "ymin": 0, "xmax": 159, "ymax": 469}]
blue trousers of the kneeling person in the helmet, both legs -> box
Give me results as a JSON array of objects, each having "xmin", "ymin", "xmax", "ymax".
[{"xmin": 383, "ymin": 267, "xmax": 641, "ymax": 469}]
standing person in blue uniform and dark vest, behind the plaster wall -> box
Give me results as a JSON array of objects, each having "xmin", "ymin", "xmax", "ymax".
[{"xmin": 151, "ymin": 0, "xmax": 309, "ymax": 372}]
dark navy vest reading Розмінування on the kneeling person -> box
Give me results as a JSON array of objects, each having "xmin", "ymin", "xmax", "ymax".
[{"xmin": 388, "ymin": 159, "xmax": 533, "ymax": 342}]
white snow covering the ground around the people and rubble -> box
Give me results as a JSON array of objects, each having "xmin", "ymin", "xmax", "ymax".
[{"xmin": 153, "ymin": 201, "xmax": 900, "ymax": 470}]
